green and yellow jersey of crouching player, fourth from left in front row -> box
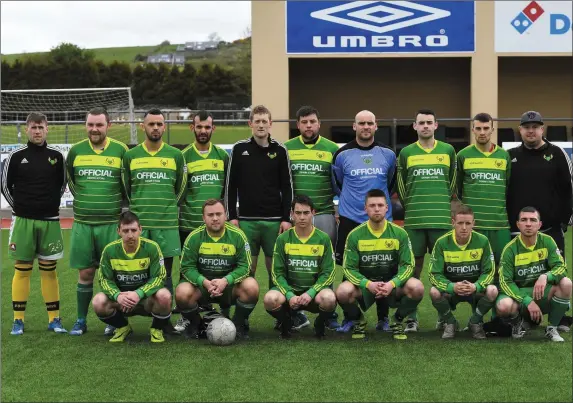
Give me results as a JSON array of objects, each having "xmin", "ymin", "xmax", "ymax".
[{"xmin": 342, "ymin": 220, "xmax": 414, "ymax": 289}]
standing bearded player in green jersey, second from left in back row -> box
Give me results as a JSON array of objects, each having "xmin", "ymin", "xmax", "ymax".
[{"xmin": 66, "ymin": 108, "xmax": 128, "ymax": 336}]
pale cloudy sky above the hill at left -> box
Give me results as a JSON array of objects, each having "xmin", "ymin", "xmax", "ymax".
[{"xmin": 0, "ymin": 1, "xmax": 251, "ymax": 54}]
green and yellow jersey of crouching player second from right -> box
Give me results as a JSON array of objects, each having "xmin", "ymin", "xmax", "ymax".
[{"xmin": 428, "ymin": 230, "xmax": 495, "ymax": 294}]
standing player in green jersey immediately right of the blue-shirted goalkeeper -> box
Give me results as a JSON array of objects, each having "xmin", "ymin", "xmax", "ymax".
[{"xmin": 397, "ymin": 109, "xmax": 456, "ymax": 332}]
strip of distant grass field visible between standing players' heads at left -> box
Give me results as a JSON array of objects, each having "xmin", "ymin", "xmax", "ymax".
[{"xmin": 0, "ymin": 124, "xmax": 251, "ymax": 148}]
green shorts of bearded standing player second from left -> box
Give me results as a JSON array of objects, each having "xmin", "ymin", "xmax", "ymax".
[{"xmin": 70, "ymin": 221, "xmax": 119, "ymax": 270}]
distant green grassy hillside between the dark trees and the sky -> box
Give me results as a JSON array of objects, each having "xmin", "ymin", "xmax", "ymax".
[{"xmin": 1, "ymin": 39, "xmax": 251, "ymax": 71}]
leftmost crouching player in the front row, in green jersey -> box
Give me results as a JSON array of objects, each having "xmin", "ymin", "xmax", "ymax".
[{"xmin": 92, "ymin": 211, "xmax": 171, "ymax": 343}]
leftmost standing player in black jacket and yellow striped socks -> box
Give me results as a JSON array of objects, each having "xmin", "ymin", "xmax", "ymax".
[{"xmin": 2, "ymin": 112, "xmax": 67, "ymax": 335}]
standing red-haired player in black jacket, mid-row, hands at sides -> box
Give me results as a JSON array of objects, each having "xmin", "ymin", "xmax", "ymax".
[{"xmin": 225, "ymin": 105, "xmax": 292, "ymax": 308}]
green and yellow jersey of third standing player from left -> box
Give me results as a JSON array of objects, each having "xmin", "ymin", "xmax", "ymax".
[{"xmin": 123, "ymin": 143, "xmax": 187, "ymax": 229}]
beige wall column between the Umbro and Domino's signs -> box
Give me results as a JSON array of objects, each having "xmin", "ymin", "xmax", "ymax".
[{"xmin": 470, "ymin": 1, "xmax": 498, "ymax": 144}]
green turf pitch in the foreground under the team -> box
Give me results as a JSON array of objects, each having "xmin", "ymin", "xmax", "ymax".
[{"xmin": 0, "ymin": 230, "xmax": 572, "ymax": 402}]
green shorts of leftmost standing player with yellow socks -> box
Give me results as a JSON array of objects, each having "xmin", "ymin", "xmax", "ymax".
[{"xmin": 8, "ymin": 216, "xmax": 64, "ymax": 262}]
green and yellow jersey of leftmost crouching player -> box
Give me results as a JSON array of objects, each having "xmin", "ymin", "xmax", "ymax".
[{"xmin": 98, "ymin": 237, "xmax": 166, "ymax": 301}]
